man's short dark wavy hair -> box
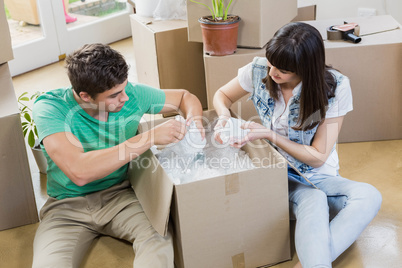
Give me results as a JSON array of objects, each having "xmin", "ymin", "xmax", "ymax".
[{"xmin": 66, "ymin": 43, "xmax": 129, "ymax": 98}]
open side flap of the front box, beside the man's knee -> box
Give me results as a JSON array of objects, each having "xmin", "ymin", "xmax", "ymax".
[{"xmin": 128, "ymin": 150, "xmax": 173, "ymax": 236}]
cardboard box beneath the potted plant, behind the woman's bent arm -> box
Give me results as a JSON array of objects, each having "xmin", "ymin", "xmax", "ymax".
[{"xmin": 204, "ymin": 48, "xmax": 265, "ymax": 122}]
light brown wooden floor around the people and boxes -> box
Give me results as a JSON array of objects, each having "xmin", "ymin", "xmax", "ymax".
[{"xmin": 0, "ymin": 38, "xmax": 402, "ymax": 268}]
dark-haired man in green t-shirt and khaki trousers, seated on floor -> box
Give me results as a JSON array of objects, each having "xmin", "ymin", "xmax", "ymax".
[{"xmin": 33, "ymin": 44, "xmax": 204, "ymax": 268}]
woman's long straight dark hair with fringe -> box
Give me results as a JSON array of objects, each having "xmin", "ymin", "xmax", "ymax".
[{"xmin": 263, "ymin": 22, "xmax": 336, "ymax": 130}]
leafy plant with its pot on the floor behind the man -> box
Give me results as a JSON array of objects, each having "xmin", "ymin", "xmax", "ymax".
[{"xmin": 18, "ymin": 92, "xmax": 47, "ymax": 174}]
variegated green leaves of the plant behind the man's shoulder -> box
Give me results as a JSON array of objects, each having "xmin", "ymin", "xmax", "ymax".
[{"xmin": 18, "ymin": 91, "xmax": 43, "ymax": 148}]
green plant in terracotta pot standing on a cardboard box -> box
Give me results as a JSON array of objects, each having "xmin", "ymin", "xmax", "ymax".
[{"xmin": 190, "ymin": 0, "xmax": 240, "ymax": 56}]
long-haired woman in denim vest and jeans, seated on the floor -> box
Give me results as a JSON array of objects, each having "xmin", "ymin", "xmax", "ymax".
[{"xmin": 214, "ymin": 22, "xmax": 382, "ymax": 268}]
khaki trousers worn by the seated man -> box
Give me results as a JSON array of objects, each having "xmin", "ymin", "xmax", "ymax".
[{"xmin": 32, "ymin": 180, "xmax": 173, "ymax": 268}]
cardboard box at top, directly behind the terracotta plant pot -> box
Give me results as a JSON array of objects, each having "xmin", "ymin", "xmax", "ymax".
[{"xmin": 187, "ymin": 0, "xmax": 297, "ymax": 48}]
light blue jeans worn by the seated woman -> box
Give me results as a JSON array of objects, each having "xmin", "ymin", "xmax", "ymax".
[{"xmin": 288, "ymin": 171, "xmax": 382, "ymax": 268}]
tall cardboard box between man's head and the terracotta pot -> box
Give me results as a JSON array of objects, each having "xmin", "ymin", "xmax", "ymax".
[{"xmin": 130, "ymin": 14, "xmax": 207, "ymax": 108}]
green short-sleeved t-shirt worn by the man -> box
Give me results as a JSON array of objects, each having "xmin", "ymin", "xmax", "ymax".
[{"xmin": 33, "ymin": 83, "xmax": 165, "ymax": 199}]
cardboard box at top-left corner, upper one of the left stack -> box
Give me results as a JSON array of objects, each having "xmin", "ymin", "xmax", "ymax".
[{"xmin": 0, "ymin": 0, "xmax": 14, "ymax": 64}]
